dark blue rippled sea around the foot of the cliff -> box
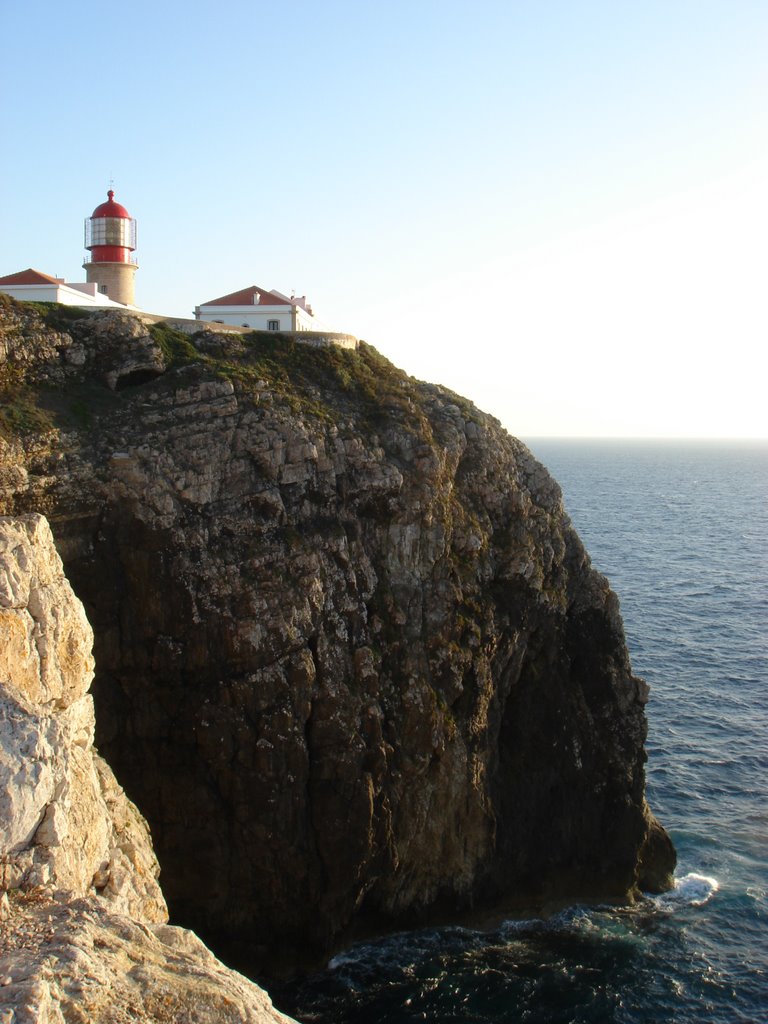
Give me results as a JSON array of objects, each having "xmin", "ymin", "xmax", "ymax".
[{"xmin": 273, "ymin": 439, "xmax": 768, "ymax": 1024}]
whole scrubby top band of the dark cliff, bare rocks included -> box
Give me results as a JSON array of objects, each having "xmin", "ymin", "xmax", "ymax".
[{"xmin": 0, "ymin": 295, "xmax": 482, "ymax": 439}]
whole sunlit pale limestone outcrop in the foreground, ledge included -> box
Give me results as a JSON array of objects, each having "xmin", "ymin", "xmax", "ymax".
[{"xmin": 0, "ymin": 515, "xmax": 296, "ymax": 1024}]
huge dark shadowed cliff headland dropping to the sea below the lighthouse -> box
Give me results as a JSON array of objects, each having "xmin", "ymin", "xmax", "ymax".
[{"xmin": 0, "ymin": 303, "xmax": 674, "ymax": 965}]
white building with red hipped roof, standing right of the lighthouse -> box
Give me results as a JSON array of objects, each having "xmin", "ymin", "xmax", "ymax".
[{"xmin": 195, "ymin": 285, "xmax": 324, "ymax": 331}]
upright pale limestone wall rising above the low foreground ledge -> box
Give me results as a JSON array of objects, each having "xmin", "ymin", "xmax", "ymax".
[{"xmin": 0, "ymin": 515, "xmax": 167, "ymax": 921}]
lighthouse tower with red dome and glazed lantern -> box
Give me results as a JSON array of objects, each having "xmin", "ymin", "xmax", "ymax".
[{"xmin": 83, "ymin": 189, "xmax": 138, "ymax": 306}]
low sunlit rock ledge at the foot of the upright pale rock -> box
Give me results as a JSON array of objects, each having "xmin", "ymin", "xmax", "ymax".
[{"xmin": 0, "ymin": 893, "xmax": 291, "ymax": 1024}]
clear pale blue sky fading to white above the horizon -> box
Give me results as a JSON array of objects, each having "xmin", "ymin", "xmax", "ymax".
[{"xmin": 0, "ymin": 0, "xmax": 768, "ymax": 438}]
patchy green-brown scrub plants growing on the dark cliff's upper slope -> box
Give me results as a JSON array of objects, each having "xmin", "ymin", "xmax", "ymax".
[{"xmin": 0, "ymin": 296, "xmax": 448, "ymax": 434}]
